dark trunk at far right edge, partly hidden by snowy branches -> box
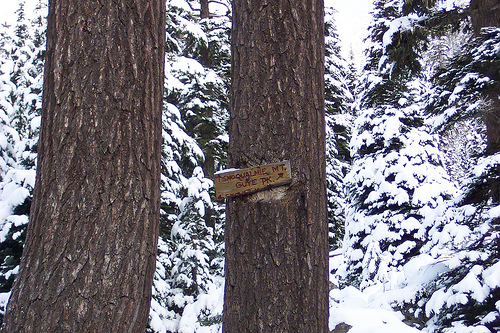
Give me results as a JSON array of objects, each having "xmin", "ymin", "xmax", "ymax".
[{"xmin": 470, "ymin": 0, "xmax": 500, "ymax": 202}]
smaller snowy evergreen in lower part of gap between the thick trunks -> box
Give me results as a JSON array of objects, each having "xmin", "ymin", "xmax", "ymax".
[{"xmin": 150, "ymin": 102, "xmax": 222, "ymax": 332}]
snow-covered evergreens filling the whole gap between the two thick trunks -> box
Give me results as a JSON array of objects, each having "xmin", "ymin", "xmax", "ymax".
[{"xmin": 150, "ymin": 1, "xmax": 230, "ymax": 332}]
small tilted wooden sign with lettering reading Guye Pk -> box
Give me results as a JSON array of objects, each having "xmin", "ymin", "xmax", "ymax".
[{"xmin": 214, "ymin": 161, "xmax": 292, "ymax": 200}]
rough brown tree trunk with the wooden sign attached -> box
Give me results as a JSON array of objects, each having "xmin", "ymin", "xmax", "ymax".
[{"xmin": 223, "ymin": 0, "xmax": 328, "ymax": 333}]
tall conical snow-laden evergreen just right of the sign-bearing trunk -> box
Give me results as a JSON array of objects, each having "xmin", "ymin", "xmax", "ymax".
[{"xmin": 344, "ymin": 1, "xmax": 456, "ymax": 288}]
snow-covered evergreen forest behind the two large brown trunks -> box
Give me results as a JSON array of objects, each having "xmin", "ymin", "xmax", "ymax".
[{"xmin": 0, "ymin": 0, "xmax": 500, "ymax": 332}]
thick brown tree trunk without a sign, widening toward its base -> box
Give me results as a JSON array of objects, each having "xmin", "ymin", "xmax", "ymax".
[{"xmin": 2, "ymin": 0, "xmax": 165, "ymax": 333}]
